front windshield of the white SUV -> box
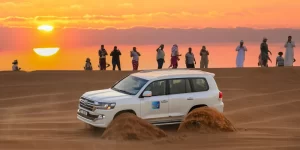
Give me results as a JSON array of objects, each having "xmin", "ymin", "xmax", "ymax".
[{"xmin": 112, "ymin": 76, "xmax": 148, "ymax": 95}]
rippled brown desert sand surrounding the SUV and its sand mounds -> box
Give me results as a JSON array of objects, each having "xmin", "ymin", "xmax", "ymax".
[{"xmin": 0, "ymin": 67, "xmax": 300, "ymax": 150}]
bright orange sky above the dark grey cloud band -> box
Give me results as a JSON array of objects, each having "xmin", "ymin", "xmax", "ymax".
[{"xmin": 0, "ymin": 0, "xmax": 300, "ymax": 28}]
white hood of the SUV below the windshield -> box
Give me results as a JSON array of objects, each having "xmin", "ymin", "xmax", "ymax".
[{"xmin": 82, "ymin": 89, "xmax": 133, "ymax": 102}]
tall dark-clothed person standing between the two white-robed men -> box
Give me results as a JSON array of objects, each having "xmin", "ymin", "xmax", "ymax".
[{"xmin": 260, "ymin": 37, "xmax": 272, "ymax": 67}]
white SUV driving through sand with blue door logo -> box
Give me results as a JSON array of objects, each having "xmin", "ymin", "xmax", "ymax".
[{"xmin": 77, "ymin": 69, "xmax": 224, "ymax": 128}]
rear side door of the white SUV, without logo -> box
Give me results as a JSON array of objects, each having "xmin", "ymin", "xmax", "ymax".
[{"xmin": 168, "ymin": 79, "xmax": 194, "ymax": 122}]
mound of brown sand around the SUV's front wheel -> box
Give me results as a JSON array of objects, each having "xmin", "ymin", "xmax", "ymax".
[{"xmin": 102, "ymin": 113, "xmax": 167, "ymax": 140}]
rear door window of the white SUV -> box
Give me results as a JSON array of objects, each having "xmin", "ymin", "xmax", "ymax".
[{"xmin": 169, "ymin": 79, "xmax": 191, "ymax": 94}]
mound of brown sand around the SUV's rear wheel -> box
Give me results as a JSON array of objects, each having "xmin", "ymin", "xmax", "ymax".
[{"xmin": 178, "ymin": 107, "xmax": 236, "ymax": 133}]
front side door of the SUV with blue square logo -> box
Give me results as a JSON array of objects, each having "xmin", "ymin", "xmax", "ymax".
[{"xmin": 140, "ymin": 80, "xmax": 170, "ymax": 124}]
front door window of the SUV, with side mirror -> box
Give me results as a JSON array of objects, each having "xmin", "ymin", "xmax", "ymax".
[{"xmin": 145, "ymin": 80, "xmax": 166, "ymax": 96}]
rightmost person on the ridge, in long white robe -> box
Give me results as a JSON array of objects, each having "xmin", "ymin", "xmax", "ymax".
[{"xmin": 284, "ymin": 36, "xmax": 295, "ymax": 66}]
